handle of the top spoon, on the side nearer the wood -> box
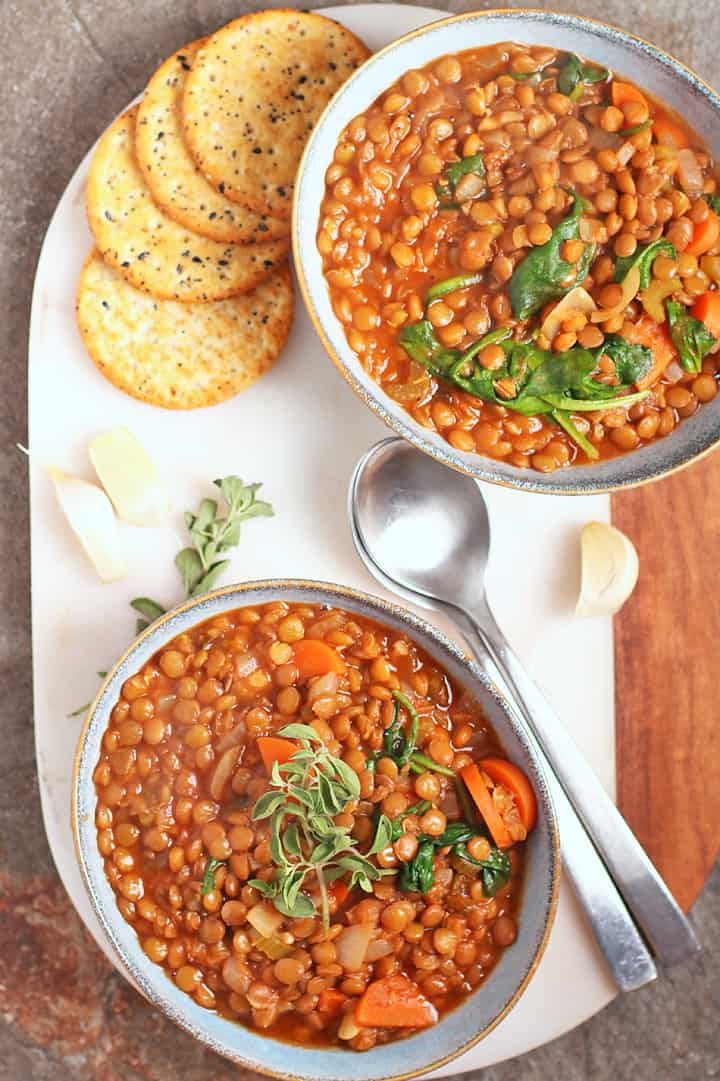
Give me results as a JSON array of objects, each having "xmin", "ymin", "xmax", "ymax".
[{"xmin": 464, "ymin": 600, "xmax": 699, "ymax": 965}]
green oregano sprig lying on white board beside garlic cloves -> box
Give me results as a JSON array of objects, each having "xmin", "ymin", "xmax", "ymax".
[{"xmin": 130, "ymin": 476, "xmax": 274, "ymax": 633}]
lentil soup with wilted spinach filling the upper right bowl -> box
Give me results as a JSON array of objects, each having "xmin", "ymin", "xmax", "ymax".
[{"xmin": 318, "ymin": 43, "xmax": 720, "ymax": 472}]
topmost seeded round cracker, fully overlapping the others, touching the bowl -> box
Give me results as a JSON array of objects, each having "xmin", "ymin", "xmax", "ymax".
[{"xmin": 183, "ymin": 11, "xmax": 370, "ymax": 219}]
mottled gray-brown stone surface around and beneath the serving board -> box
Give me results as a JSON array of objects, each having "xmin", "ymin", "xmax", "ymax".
[{"xmin": 0, "ymin": 0, "xmax": 720, "ymax": 1081}]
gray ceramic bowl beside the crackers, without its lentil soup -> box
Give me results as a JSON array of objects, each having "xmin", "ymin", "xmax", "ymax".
[{"xmin": 293, "ymin": 10, "xmax": 720, "ymax": 495}]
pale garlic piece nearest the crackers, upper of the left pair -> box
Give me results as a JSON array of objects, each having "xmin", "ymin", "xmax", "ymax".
[{"xmin": 88, "ymin": 428, "xmax": 170, "ymax": 526}]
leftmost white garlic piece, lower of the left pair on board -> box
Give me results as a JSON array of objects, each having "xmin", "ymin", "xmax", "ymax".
[{"xmin": 48, "ymin": 466, "xmax": 125, "ymax": 582}]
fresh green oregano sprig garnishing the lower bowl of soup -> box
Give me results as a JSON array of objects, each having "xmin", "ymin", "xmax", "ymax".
[{"xmin": 250, "ymin": 723, "xmax": 392, "ymax": 927}]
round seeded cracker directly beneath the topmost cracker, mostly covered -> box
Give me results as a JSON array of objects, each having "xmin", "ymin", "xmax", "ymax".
[{"xmin": 135, "ymin": 38, "xmax": 288, "ymax": 244}]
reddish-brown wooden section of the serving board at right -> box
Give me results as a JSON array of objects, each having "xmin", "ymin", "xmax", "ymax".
[{"xmin": 612, "ymin": 452, "xmax": 720, "ymax": 910}]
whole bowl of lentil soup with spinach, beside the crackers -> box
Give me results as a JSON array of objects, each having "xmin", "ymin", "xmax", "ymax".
[{"xmin": 294, "ymin": 11, "xmax": 720, "ymax": 494}]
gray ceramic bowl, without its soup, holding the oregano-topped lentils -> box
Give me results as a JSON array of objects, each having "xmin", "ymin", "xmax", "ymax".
[{"xmin": 72, "ymin": 580, "xmax": 559, "ymax": 1081}]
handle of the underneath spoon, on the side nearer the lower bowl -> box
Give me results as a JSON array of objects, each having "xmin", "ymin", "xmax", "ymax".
[{"xmin": 453, "ymin": 613, "xmax": 657, "ymax": 991}]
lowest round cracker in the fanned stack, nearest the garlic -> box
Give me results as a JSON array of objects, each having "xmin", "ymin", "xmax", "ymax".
[{"xmin": 77, "ymin": 251, "xmax": 293, "ymax": 409}]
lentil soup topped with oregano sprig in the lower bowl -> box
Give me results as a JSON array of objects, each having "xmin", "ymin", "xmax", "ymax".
[{"xmin": 94, "ymin": 601, "xmax": 536, "ymax": 1051}]
